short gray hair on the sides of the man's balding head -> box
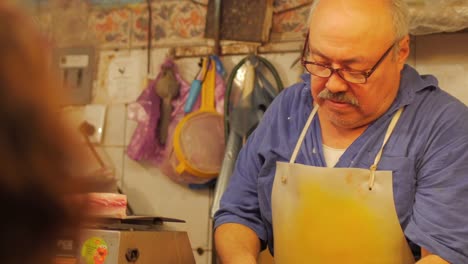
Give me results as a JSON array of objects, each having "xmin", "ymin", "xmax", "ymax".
[{"xmin": 307, "ymin": 0, "xmax": 409, "ymax": 41}]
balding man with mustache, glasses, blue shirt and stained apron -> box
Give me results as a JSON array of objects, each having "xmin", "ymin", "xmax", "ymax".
[{"xmin": 215, "ymin": 0, "xmax": 468, "ymax": 263}]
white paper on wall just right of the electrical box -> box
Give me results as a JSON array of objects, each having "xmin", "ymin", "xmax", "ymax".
[{"xmin": 107, "ymin": 56, "xmax": 143, "ymax": 103}]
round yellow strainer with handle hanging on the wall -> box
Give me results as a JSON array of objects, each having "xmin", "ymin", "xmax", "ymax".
[{"xmin": 174, "ymin": 60, "xmax": 225, "ymax": 180}]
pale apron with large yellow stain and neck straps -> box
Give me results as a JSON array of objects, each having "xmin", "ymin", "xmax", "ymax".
[{"xmin": 272, "ymin": 106, "xmax": 414, "ymax": 264}]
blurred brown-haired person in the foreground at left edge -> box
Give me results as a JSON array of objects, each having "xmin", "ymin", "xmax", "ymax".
[{"xmin": 0, "ymin": 1, "xmax": 90, "ymax": 264}]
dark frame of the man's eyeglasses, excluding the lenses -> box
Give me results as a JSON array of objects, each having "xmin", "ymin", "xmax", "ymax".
[{"xmin": 301, "ymin": 31, "xmax": 397, "ymax": 84}]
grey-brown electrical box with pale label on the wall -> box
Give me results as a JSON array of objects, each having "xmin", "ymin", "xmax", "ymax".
[{"xmin": 55, "ymin": 47, "xmax": 96, "ymax": 105}]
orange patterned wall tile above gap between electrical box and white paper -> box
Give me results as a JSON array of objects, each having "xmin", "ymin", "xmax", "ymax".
[{"xmin": 89, "ymin": 8, "xmax": 132, "ymax": 48}]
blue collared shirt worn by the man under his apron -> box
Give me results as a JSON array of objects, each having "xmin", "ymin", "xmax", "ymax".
[{"xmin": 215, "ymin": 65, "xmax": 468, "ymax": 263}]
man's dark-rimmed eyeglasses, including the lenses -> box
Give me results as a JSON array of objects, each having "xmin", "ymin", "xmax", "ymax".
[{"xmin": 301, "ymin": 32, "xmax": 396, "ymax": 84}]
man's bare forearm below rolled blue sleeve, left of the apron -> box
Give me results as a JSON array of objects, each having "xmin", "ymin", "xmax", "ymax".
[{"xmin": 215, "ymin": 223, "xmax": 260, "ymax": 264}]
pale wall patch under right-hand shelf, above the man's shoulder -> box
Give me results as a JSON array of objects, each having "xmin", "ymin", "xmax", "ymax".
[{"xmin": 416, "ymin": 64, "xmax": 468, "ymax": 105}]
